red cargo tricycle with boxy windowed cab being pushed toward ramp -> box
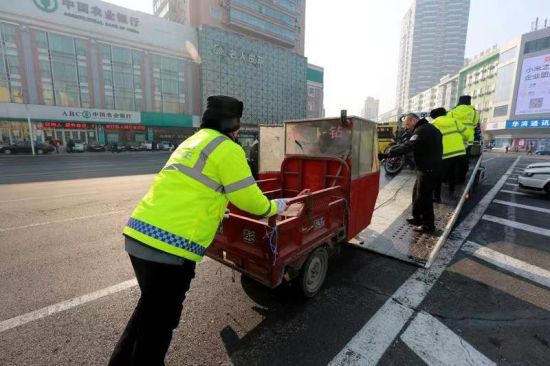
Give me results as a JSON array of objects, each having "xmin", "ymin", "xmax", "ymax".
[{"xmin": 207, "ymin": 116, "xmax": 380, "ymax": 297}]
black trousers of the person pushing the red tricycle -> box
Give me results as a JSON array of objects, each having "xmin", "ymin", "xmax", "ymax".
[{"xmin": 109, "ymin": 256, "xmax": 195, "ymax": 366}]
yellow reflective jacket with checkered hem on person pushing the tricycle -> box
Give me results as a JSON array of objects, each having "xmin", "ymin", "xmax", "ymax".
[{"xmin": 124, "ymin": 129, "xmax": 277, "ymax": 262}]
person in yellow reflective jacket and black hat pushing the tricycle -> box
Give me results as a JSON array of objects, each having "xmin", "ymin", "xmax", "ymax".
[{"xmin": 109, "ymin": 96, "xmax": 287, "ymax": 366}]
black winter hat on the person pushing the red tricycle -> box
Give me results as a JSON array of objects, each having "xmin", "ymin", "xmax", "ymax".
[{"xmin": 201, "ymin": 95, "xmax": 244, "ymax": 133}]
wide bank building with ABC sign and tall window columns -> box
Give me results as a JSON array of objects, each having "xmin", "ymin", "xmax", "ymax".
[{"xmin": 0, "ymin": 0, "xmax": 200, "ymax": 144}]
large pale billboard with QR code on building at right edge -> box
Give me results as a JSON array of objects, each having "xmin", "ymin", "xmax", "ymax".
[{"xmin": 515, "ymin": 54, "xmax": 550, "ymax": 116}]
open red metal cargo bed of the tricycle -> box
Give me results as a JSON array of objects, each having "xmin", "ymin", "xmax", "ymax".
[{"xmin": 207, "ymin": 158, "xmax": 349, "ymax": 287}]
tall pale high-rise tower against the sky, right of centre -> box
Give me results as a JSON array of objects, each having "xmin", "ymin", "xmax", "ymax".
[{"xmin": 396, "ymin": 0, "xmax": 470, "ymax": 109}]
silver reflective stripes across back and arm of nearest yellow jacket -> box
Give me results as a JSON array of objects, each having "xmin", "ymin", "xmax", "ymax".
[{"xmin": 164, "ymin": 136, "xmax": 258, "ymax": 194}]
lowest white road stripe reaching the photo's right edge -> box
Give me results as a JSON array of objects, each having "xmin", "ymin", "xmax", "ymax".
[{"xmin": 461, "ymin": 241, "xmax": 550, "ymax": 288}]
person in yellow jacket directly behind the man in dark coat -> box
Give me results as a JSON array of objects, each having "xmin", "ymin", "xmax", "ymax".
[{"xmin": 430, "ymin": 108, "xmax": 469, "ymax": 202}]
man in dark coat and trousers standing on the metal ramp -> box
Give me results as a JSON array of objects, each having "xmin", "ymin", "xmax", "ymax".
[{"xmin": 378, "ymin": 113, "xmax": 443, "ymax": 233}]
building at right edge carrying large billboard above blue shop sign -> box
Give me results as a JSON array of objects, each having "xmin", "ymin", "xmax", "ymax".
[{"xmin": 485, "ymin": 28, "xmax": 550, "ymax": 151}]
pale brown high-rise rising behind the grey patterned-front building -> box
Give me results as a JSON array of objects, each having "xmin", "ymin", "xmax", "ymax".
[{"xmin": 157, "ymin": 0, "xmax": 306, "ymax": 55}]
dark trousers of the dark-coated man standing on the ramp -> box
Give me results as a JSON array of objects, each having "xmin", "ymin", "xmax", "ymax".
[{"xmin": 413, "ymin": 171, "xmax": 440, "ymax": 227}]
